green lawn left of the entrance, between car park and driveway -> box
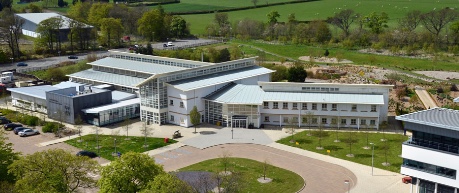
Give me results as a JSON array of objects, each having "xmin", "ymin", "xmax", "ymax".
[{"xmin": 65, "ymin": 134, "xmax": 177, "ymax": 160}]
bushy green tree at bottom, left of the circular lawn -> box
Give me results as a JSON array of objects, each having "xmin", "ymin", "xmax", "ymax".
[{"xmin": 98, "ymin": 152, "xmax": 164, "ymax": 193}]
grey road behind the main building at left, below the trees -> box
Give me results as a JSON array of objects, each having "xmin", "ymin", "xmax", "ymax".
[{"xmin": 0, "ymin": 51, "xmax": 108, "ymax": 72}]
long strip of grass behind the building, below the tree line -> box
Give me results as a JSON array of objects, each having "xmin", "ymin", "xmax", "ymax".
[{"xmin": 234, "ymin": 41, "xmax": 459, "ymax": 71}]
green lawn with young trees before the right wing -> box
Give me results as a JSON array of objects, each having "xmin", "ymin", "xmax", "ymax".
[{"xmin": 277, "ymin": 131, "xmax": 408, "ymax": 173}]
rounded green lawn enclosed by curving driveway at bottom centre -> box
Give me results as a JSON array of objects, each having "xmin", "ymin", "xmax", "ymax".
[{"xmin": 179, "ymin": 158, "xmax": 304, "ymax": 193}]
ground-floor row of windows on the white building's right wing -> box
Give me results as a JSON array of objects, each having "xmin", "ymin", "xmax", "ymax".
[{"xmin": 264, "ymin": 116, "xmax": 376, "ymax": 125}]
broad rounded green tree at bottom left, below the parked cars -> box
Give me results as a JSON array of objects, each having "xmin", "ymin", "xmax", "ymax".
[{"xmin": 9, "ymin": 149, "xmax": 97, "ymax": 192}]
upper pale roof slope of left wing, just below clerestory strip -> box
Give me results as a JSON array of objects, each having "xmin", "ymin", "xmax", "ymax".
[{"xmin": 89, "ymin": 57, "xmax": 189, "ymax": 75}]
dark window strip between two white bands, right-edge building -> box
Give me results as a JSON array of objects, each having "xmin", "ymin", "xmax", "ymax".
[{"xmin": 403, "ymin": 159, "xmax": 456, "ymax": 179}]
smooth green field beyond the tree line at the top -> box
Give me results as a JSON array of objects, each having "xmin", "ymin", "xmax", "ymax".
[{"xmin": 182, "ymin": 0, "xmax": 459, "ymax": 34}]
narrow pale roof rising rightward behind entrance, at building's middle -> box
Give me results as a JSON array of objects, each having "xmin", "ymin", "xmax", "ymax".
[{"xmin": 166, "ymin": 66, "xmax": 273, "ymax": 91}]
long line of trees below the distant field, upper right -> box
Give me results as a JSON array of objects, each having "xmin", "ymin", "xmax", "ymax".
[{"xmin": 210, "ymin": 7, "xmax": 459, "ymax": 55}]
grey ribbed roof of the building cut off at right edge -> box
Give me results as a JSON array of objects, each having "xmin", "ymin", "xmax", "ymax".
[{"xmin": 395, "ymin": 107, "xmax": 459, "ymax": 131}]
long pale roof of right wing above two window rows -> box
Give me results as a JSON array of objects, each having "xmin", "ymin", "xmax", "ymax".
[{"xmin": 263, "ymin": 92, "xmax": 384, "ymax": 105}]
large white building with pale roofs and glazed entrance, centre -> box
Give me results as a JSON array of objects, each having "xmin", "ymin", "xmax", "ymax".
[{"xmin": 68, "ymin": 51, "xmax": 392, "ymax": 128}]
